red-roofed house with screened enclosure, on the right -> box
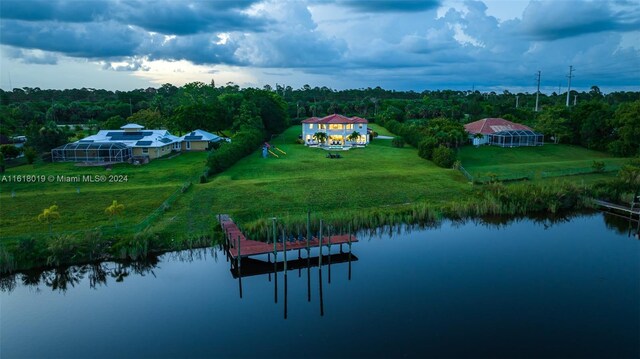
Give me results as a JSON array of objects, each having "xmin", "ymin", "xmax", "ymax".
[{"xmin": 464, "ymin": 118, "xmax": 544, "ymax": 147}]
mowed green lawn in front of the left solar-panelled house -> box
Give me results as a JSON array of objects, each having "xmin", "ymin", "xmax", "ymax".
[{"xmin": 0, "ymin": 152, "xmax": 207, "ymax": 238}]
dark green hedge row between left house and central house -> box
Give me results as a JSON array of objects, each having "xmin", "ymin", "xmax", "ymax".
[{"xmin": 207, "ymin": 127, "xmax": 264, "ymax": 176}]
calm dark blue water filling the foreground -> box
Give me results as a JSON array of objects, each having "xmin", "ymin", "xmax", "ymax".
[{"xmin": 0, "ymin": 214, "xmax": 640, "ymax": 359}]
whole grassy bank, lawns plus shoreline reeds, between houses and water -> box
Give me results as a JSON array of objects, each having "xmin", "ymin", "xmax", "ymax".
[{"xmin": 0, "ymin": 124, "xmax": 628, "ymax": 273}]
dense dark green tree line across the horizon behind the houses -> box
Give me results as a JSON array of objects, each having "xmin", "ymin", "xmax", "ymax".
[{"xmin": 0, "ymin": 82, "xmax": 640, "ymax": 156}]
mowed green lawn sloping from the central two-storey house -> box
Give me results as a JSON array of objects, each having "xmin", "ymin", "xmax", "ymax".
[{"xmin": 178, "ymin": 126, "xmax": 471, "ymax": 228}]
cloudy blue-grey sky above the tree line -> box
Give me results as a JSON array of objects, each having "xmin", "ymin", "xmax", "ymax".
[{"xmin": 0, "ymin": 0, "xmax": 640, "ymax": 93}]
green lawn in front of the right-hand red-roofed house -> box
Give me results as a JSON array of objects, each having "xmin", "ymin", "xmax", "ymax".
[{"xmin": 458, "ymin": 144, "xmax": 628, "ymax": 183}]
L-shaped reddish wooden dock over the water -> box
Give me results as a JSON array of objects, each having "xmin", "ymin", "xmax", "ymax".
[{"xmin": 218, "ymin": 214, "xmax": 358, "ymax": 259}]
